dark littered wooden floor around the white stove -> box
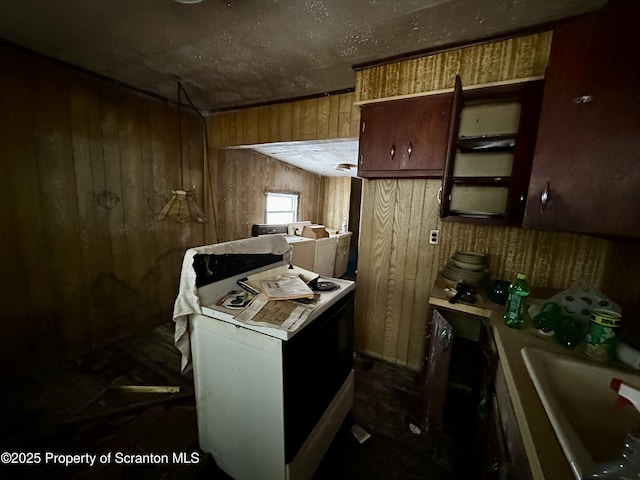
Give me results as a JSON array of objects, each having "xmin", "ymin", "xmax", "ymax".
[{"xmin": 0, "ymin": 322, "xmax": 476, "ymax": 480}]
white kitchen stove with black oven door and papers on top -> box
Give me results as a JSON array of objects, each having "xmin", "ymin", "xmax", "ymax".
[{"xmin": 189, "ymin": 237, "xmax": 354, "ymax": 480}]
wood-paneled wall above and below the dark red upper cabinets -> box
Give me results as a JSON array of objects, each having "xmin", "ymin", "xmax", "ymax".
[{"xmin": 356, "ymin": 33, "xmax": 632, "ymax": 368}]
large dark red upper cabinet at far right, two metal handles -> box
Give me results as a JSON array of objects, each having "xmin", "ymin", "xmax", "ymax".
[{"xmin": 524, "ymin": 0, "xmax": 640, "ymax": 237}]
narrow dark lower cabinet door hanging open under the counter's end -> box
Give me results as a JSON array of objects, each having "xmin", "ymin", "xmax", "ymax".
[{"xmin": 422, "ymin": 310, "xmax": 453, "ymax": 448}]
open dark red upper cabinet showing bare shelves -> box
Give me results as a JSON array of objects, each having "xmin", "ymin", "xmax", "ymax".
[{"xmin": 440, "ymin": 77, "xmax": 543, "ymax": 225}]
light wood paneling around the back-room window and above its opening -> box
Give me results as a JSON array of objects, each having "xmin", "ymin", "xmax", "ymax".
[{"xmin": 207, "ymin": 93, "xmax": 360, "ymax": 241}]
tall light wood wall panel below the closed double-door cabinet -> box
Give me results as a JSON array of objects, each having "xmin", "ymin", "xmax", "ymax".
[{"xmin": 355, "ymin": 179, "xmax": 440, "ymax": 368}]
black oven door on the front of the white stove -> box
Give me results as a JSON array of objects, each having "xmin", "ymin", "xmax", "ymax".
[{"xmin": 283, "ymin": 292, "xmax": 354, "ymax": 463}]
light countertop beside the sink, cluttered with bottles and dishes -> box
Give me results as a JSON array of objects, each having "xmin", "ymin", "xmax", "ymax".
[{"xmin": 429, "ymin": 279, "xmax": 586, "ymax": 480}]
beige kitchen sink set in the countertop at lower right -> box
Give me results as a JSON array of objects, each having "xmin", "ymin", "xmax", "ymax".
[{"xmin": 521, "ymin": 347, "xmax": 640, "ymax": 479}]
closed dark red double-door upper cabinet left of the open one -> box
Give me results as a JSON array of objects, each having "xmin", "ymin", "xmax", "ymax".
[{"xmin": 358, "ymin": 93, "xmax": 453, "ymax": 178}]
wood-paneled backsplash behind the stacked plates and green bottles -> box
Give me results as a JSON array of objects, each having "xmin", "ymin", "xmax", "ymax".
[{"xmin": 438, "ymin": 222, "xmax": 640, "ymax": 349}]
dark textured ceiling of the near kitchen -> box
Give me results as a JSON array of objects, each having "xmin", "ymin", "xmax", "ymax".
[{"xmin": 0, "ymin": 0, "xmax": 605, "ymax": 176}]
